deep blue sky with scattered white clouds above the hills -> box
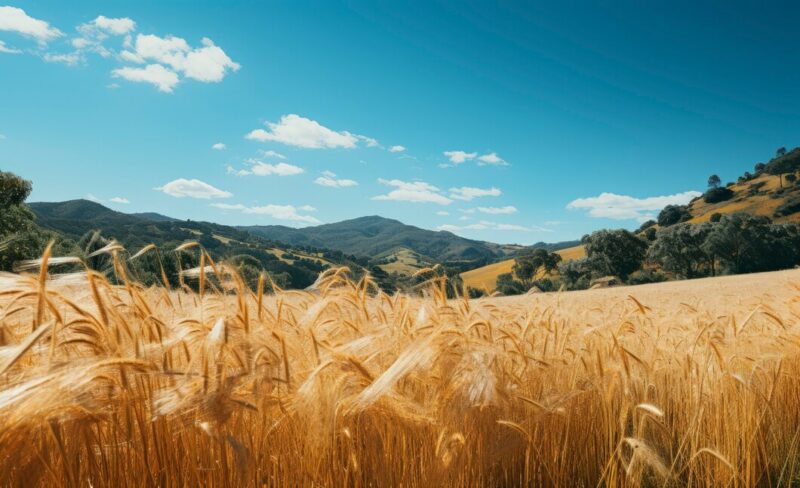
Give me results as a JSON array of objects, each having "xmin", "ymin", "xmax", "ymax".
[{"xmin": 0, "ymin": 0, "xmax": 800, "ymax": 244}]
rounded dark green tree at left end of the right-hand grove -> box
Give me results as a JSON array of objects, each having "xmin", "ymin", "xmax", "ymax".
[{"xmin": 583, "ymin": 229, "xmax": 647, "ymax": 280}]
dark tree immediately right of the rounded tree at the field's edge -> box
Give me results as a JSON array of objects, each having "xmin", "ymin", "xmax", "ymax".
[{"xmin": 647, "ymin": 223, "xmax": 714, "ymax": 278}]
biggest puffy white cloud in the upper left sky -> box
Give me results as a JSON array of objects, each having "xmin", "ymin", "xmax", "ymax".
[{"xmin": 121, "ymin": 34, "xmax": 241, "ymax": 83}]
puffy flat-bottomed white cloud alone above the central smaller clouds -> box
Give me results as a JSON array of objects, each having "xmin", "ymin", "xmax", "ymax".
[{"xmin": 245, "ymin": 114, "xmax": 362, "ymax": 149}]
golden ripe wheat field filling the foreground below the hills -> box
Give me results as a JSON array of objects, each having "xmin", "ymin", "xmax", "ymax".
[{"xmin": 0, "ymin": 245, "xmax": 800, "ymax": 487}]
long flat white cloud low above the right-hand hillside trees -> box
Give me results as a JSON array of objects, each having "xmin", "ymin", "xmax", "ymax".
[{"xmin": 567, "ymin": 191, "xmax": 702, "ymax": 221}]
